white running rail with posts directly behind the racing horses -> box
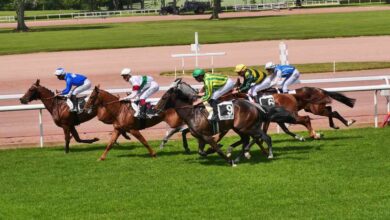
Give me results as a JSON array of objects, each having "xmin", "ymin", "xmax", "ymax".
[{"xmin": 0, "ymin": 75, "xmax": 390, "ymax": 147}]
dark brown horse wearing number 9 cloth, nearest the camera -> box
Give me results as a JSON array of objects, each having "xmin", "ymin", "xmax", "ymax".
[{"xmin": 155, "ymin": 79, "xmax": 294, "ymax": 166}]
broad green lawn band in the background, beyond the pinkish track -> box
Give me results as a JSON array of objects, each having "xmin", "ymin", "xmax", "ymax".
[{"xmin": 0, "ymin": 11, "xmax": 390, "ymax": 54}]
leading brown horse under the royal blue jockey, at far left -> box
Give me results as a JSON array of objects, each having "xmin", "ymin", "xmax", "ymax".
[{"xmin": 20, "ymin": 79, "xmax": 99, "ymax": 153}]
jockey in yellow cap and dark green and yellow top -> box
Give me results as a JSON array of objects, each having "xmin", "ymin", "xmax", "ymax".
[{"xmin": 234, "ymin": 64, "xmax": 267, "ymax": 97}]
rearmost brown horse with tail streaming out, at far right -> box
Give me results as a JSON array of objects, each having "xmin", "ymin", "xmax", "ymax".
[{"xmin": 261, "ymin": 87, "xmax": 356, "ymax": 139}]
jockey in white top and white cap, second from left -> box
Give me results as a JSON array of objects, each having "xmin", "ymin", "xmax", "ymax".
[{"xmin": 120, "ymin": 68, "xmax": 160, "ymax": 118}]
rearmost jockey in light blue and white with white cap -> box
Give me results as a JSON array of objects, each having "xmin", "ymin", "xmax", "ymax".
[{"xmin": 265, "ymin": 62, "xmax": 300, "ymax": 93}]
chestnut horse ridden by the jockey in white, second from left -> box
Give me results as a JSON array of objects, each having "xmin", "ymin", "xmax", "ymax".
[{"xmin": 84, "ymin": 86, "xmax": 184, "ymax": 160}]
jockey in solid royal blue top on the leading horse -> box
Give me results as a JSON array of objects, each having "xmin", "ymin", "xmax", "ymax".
[{"xmin": 54, "ymin": 68, "xmax": 91, "ymax": 112}]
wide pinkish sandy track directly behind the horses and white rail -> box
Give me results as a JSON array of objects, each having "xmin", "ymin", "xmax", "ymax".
[{"xmin": 0, "ymin": 7, "xmax": 390, "ymax": 148}]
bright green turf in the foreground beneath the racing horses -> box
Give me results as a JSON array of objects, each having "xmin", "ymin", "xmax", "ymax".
[{"xmin": 0, "ymin": 128, "xmax": 390, "ymax": 219}]
